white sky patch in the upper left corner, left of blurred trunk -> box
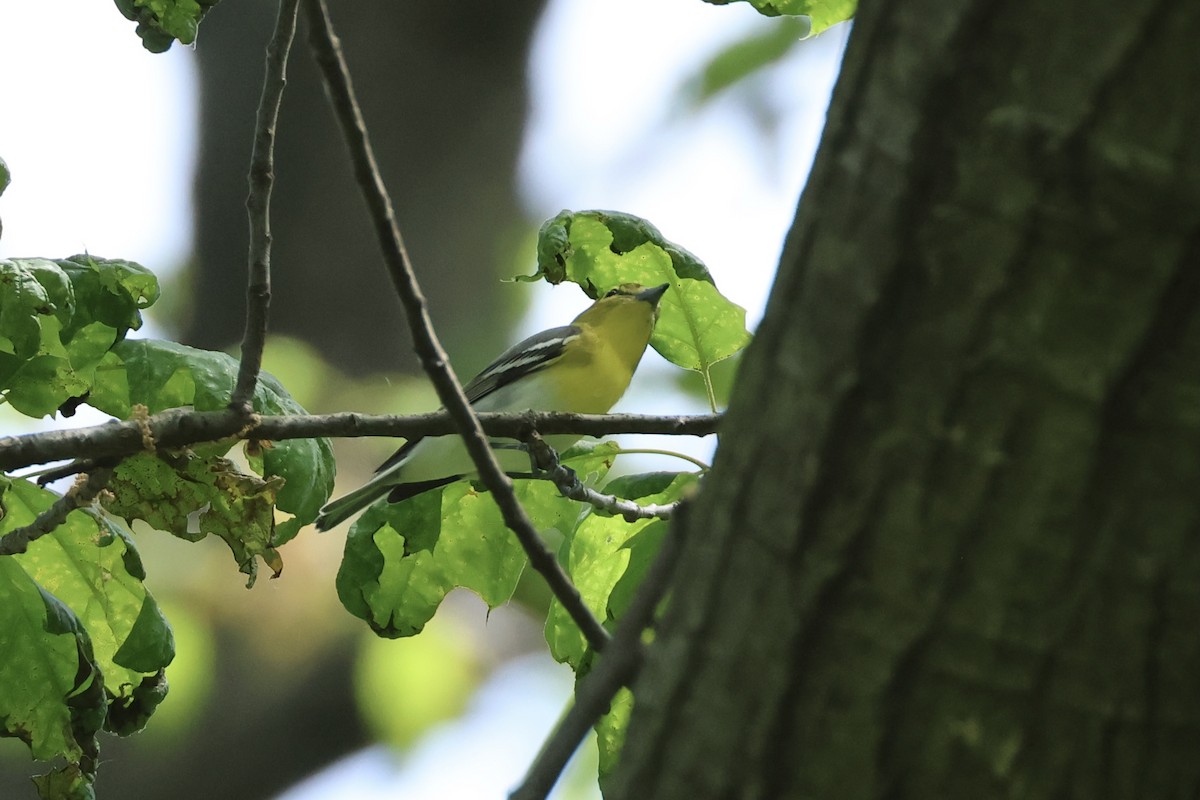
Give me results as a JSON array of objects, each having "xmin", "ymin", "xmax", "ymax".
[{"xmin": 0, "ymin": 0, "xmax": 197, "ymax": 272}]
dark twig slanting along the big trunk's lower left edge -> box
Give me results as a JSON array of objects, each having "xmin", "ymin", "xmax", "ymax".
[{"xmin": 509, "ymin": 505, "xmax": 688, "ymax": 800}]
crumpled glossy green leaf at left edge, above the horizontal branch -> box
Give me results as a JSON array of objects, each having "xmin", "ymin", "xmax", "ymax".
[{"xmin": 0, "ymin": 255, "xmax": 158, "ymax": 416}]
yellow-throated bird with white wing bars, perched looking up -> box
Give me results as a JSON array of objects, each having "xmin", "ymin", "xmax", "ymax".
[{"xmin": 314, "ymin": 283, "xmax": 671, "ymax": 530}]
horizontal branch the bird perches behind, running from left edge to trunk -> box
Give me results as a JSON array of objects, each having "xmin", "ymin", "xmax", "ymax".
[{"xmin": 0, "ymin": 409, "xmax": 721, "ymax": 471}]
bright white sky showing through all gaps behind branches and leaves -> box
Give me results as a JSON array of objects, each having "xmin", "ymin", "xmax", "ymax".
[{"xmin": 0, "ymin": 0, "xmax": 846, "ymax": 800}]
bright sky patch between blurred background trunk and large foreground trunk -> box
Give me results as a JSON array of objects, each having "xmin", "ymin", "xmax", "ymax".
[{"xmin": 521, "ymin": 0, "xmax": 846, "ymax": 329}]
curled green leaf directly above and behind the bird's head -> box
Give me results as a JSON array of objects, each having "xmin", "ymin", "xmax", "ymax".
[{"xmin": 533, "ymin": 211, "xmax": 750, "ymax": 383}]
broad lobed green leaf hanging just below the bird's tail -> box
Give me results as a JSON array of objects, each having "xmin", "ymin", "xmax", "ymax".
[{"xmin": 337, "ymin": 443, "xmax": 617, "ymax": 638}]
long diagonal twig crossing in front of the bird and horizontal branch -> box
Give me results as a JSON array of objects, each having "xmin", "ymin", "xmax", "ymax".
[{"xmin": 305, "ymin": 0, "xmax": 608, "ymax": 650}]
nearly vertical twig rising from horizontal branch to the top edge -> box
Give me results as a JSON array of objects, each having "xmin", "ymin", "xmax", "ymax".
[{"xmin": 229, "ymin": 0, "xmax": 300, "ymax": 414}]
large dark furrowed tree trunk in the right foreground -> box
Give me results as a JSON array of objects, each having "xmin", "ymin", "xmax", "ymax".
[{"xmin": 610, "ymin": 0, "xmax": 1200, "ymax": 800}]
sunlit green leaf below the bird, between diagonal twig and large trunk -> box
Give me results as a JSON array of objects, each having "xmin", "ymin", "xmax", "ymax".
[{"xmin": 546, "ymin": 473, "xmax": 697, "ymax": 673}]
